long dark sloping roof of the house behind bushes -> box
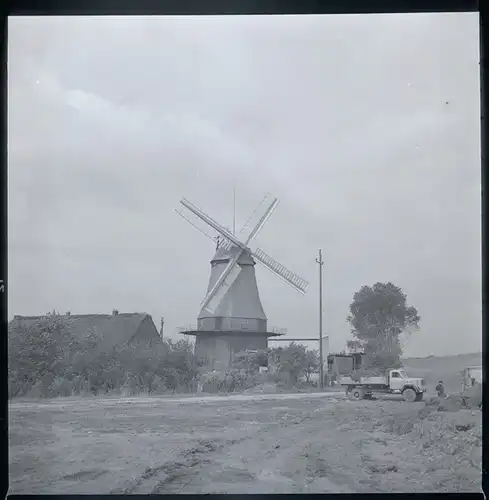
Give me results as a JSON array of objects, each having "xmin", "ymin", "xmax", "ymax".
[{"xmin": 13, "ymin": 313, "xmax": 159, "ymax": 350}]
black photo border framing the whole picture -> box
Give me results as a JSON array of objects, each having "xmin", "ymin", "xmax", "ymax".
[{"xmin": 0, "ymin": 0, "xmax": 489, "ymax": 500}]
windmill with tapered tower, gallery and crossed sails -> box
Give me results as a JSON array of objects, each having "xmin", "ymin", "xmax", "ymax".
[{"xmin": 177, "ymin": 193, "xmax": 308, "ymax": 368}]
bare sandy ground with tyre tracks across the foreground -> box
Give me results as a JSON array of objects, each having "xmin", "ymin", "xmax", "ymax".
[{"xmin": 9, "ymin": 393, "xmax": 482, "ymax": 494}]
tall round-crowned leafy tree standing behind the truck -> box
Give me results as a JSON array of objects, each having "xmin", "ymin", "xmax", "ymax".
[{"xmin": 347, "ymin": 282, "xmax": 420, "ymax": 369}]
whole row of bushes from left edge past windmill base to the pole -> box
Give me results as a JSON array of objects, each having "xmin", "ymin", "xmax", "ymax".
[{"xmin": 8, "ymin": 312, "xmax": 319, "ymax": 398}]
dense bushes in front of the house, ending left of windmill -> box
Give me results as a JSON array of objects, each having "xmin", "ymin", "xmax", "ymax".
[{"xmin": 8, "ymin": 312, "xmax": 197, "ymax": 397}]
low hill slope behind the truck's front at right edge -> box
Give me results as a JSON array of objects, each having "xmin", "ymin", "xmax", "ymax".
[{"xmin": 403, "ymin": 352, "xmax": 482, "ymax": 393}]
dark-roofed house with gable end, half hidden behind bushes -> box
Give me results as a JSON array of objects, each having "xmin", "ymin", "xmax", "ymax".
[{"xmin": 12, "ymin": 310, "xmax": 162, "ymax": 352}]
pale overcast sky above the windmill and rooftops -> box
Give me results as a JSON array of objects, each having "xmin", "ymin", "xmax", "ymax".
[{"xmin": 8, "ymin": 13, "xmax": 482, "ymax": 356}]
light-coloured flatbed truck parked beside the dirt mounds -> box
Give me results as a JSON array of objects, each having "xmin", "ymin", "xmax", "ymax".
[{"xmin": 339, "ymin": 369, "xmax": 426, "ymax": 402}]
